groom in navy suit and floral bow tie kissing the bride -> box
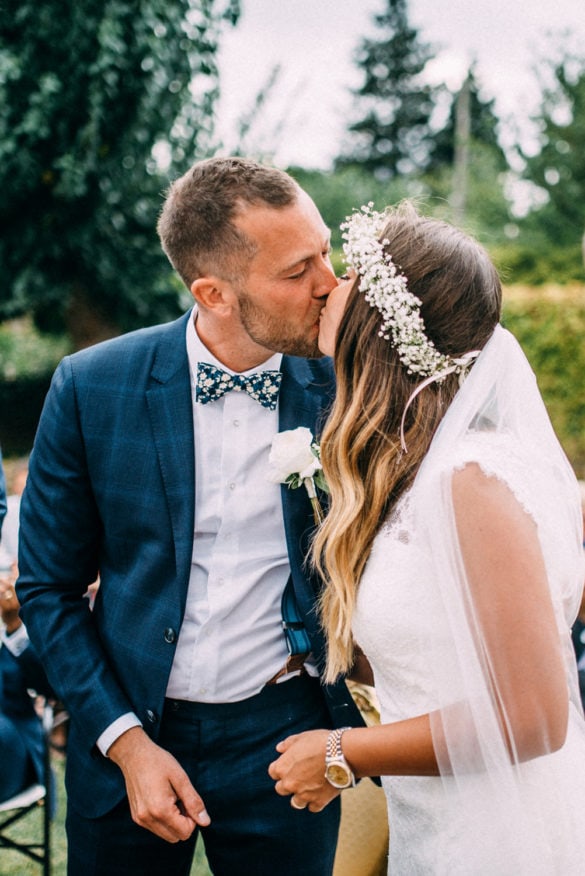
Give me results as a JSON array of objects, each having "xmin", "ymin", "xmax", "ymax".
[{"xmin": 18, "ymin": 158, "xmax": 360, "ymax": 876}]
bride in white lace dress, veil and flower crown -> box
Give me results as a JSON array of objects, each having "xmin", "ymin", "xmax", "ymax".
[{"xmin": 270, "ymin": 204, "xmax": 585, "ymax": 876}]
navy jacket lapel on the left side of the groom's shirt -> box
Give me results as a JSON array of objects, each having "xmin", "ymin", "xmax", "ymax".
[{"xmin": 146, "ymin": 311, "xmax": 195, "ymax": 582}]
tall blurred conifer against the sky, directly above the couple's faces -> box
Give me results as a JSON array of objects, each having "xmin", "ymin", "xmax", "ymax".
[{"xmin": 337, "ymin": 0, "xmax": 434, "ymax": 178}]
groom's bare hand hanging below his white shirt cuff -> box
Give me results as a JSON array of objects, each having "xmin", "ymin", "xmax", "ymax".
[{"xmin": 108, "ymin": 727, "xmax": 210, "ymax": 843}]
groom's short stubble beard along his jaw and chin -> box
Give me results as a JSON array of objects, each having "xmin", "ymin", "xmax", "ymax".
[{"xmin": 238, "ymin": 289, "xmax": 323, "ymax": 359}]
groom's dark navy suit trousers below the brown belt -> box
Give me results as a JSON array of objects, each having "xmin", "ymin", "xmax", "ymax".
[{"xmin": 67, "ymin": 676, "xmax": 339, "ymax": 876}]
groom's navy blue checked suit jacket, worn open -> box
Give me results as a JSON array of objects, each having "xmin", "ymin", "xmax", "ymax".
[{"xmin": 17, "ymin": 314, "xmax": 361, "ymax": 817}]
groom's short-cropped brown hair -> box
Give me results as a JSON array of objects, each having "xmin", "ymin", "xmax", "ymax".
[{"xmin": 158, "ymin": 157, "xmax": 300, "ymax": 288}]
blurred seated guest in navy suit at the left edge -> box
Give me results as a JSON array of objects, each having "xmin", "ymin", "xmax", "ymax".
[{"xmin": 0, "ymin": 576, "xmax": 51, "ymax": 803}]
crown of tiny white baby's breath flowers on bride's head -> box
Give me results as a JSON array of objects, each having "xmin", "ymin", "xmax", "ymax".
[{"xmin": 341, "ymin": 202, "xmax": 477, "ymax": 380}]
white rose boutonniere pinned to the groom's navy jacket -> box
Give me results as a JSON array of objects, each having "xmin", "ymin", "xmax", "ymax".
[{"xmin": 268, "ymin": 426, "xmax": 327, "ymax": 525}]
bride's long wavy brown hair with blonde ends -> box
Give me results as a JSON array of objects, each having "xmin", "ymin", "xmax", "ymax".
[{"xmin": 313, "ymin": 202, "xmax": 502, "ymax": 681}]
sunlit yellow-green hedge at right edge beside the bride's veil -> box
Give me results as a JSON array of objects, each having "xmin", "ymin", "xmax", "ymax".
[{"xmin": 504, "ymin": 287, "xmax": 585, "ymax": 478}]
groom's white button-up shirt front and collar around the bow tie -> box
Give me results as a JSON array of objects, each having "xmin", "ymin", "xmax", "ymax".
[{"xmin": 167, "ymin": 312, "xmax": 290, "ymax": 703}]
